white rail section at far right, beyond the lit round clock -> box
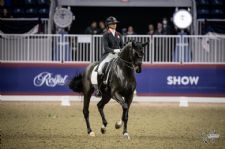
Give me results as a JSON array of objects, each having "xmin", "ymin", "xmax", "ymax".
[{"xmin": 182, "ymin": 35, "xmax": 225, "ymax": 64}]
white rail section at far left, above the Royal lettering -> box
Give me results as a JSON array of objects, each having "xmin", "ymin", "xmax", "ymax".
[{"xmin": 0, "ymin": 34, "xmax": 63, "ymax": 62}]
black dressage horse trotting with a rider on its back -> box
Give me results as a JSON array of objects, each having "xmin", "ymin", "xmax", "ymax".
[{"xmin": 69, "ymin": 41, "xmax": 148, "ymax": 139}]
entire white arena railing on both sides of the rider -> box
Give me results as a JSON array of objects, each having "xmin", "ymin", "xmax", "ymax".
[{"xmin": 0, "ymin": 34, "xmax": 225, "ymax": 64}]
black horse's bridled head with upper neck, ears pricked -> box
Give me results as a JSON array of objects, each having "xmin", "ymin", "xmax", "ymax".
[{"xmin": 121, "ymin": 41, "xmax": 148, "ymax": 73}]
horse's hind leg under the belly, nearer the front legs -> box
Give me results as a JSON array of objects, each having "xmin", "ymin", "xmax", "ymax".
[{"xmin": 97, "ymin": 96, "xmax": 110, "ymax": 134}]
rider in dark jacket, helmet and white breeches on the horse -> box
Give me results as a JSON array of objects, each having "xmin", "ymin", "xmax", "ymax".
[{"xmin": 97, "ymin": 16, "xmax": 123, "ymax": 95}]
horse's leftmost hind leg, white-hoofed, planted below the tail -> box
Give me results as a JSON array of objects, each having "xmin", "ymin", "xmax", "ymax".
[{"xmin": 83, "ymin": 93, "xmax": 95, "ymax": 136}]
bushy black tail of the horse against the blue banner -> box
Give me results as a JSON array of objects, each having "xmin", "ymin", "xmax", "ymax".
[{"xmin": 69, "ymin": 73, "xmax": 83, "ymax": 93}]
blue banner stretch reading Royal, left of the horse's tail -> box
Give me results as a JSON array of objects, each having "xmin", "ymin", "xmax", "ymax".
[{"xmin": 0, "ymin": 64, "xmax": 86, "ymax": 94}]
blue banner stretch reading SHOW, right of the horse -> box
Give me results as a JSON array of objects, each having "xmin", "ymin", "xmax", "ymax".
[{"xmin": 137, "ymin": 65, "xmax": 225, "ymax": 96}]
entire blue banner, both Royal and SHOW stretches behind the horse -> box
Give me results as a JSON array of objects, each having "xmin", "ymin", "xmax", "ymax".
[{"xmin": 0, "ymin": 64, "xmax": 225, "ymax": 97}]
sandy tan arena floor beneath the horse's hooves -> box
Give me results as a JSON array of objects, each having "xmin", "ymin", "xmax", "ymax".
[{"xmin": 0, "ymin": 97, "xmax": 225, "ymax": 149}]
